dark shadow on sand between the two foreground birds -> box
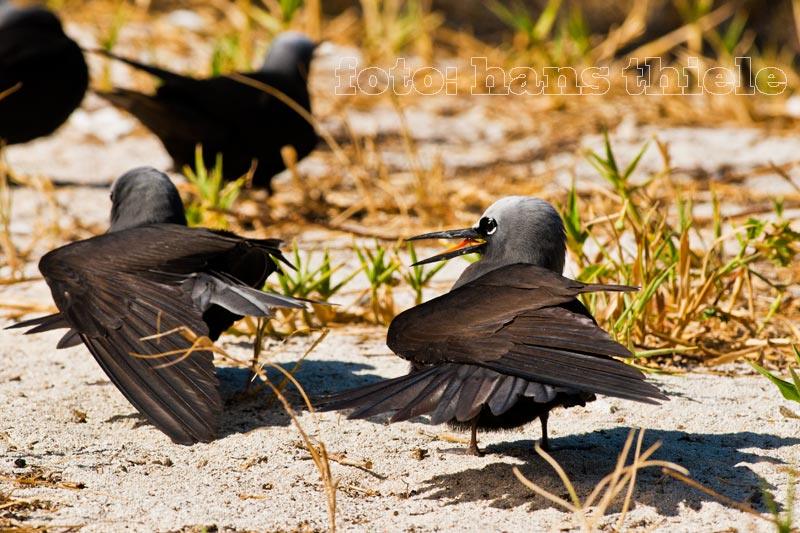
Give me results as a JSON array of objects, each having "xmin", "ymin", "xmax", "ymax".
[{"xmin": 212, "ymin": 360, "xmax": 383, "ymax": 437}]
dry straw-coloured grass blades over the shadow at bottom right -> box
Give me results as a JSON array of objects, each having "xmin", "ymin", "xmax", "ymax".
[{"xmin": 513, "ymin": 429, "xmax": 689, "ymax": 533}]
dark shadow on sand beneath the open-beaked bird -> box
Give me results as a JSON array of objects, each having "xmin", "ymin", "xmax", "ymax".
[{"xmin": 417, "ymin": 427, "xmax": 800, "ymax": 516}]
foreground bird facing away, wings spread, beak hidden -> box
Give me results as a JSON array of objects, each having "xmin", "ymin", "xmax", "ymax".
[{"xmin": 12, "ymin": 167, "xmax": 304, "ymax": 444}]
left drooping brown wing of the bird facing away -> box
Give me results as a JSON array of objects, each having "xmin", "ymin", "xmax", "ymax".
[{"xmin": 31, "ymin": 231, "xmax": 222, "ymax": 444}]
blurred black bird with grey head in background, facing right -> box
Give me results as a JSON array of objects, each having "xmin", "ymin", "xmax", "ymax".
[{"xmin": 99, "ymin": 32, "xmax": 317, "ymax": 190}]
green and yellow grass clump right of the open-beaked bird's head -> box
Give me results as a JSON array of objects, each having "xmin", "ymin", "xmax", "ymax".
[{"xmin": 561, "ymin": 134, "xmax": 800, "ymax": 370}]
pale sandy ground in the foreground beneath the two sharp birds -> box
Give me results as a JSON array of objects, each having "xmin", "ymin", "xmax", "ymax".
[{"xmin": 0, "ymin": 320, "xmax": 800, "ymax": 532}]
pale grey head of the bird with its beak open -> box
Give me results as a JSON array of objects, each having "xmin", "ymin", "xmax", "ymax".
[{"xmin": 409, "ymin": 196, "xmax": 566, "ymax": 274}]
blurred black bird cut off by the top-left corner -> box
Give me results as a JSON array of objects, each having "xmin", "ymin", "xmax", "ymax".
[{"xmin": 0, "ymin": 2, "xmax": 89, "ymax": 144}]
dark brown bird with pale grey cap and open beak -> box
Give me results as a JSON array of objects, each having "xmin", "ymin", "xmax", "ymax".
[{"xmin": 318, "ymin": 196, "xmax": 667, "ymax": 455}]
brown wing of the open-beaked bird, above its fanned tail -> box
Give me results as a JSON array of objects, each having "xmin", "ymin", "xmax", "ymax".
[{"xmin": 387, "ymin": 264, "xmax": 664, "ymax": 403}]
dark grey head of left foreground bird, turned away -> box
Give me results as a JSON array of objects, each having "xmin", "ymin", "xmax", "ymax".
[{"xmin": 108, "ymin": 167, "xmax": 186, "ymax": 233}]
